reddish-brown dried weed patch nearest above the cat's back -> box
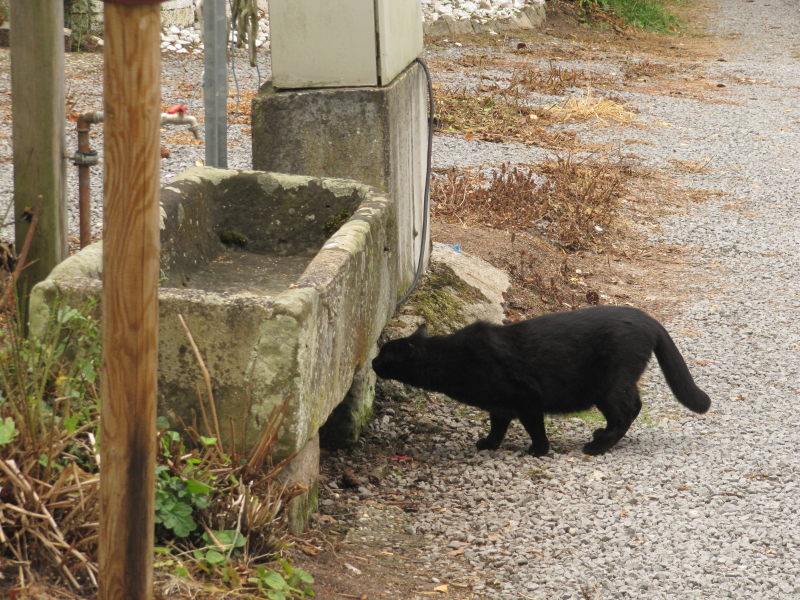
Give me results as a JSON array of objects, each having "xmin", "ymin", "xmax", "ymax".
[{"xmin": 431, "ymin": 156, "xmax": 629, "ymax": 250}]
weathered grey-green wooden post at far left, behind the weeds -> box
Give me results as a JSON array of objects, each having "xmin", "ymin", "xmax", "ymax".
[{"xmin": 10, "ymin": 0, "xmax": 67, "ymax": 326}]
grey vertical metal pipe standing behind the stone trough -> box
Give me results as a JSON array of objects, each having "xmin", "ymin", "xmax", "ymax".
[{"xmin": 203, "ymin": 0, "xmax": 228, "ymax": 169}]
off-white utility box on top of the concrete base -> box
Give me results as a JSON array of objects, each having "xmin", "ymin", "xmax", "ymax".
[{"xmin": 269, "ymin": 0, "xmax": 423, "ymax": 88}]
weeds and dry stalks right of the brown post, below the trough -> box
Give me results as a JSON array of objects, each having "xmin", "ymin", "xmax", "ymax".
[{"xmin": 150, "ymin": 404, "xmax": 310, "ymax": 598}]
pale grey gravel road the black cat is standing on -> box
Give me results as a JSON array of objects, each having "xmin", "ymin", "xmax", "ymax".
[{"xmin": 376, "ymin": 0, "xmax": 800, "ymax": 600}]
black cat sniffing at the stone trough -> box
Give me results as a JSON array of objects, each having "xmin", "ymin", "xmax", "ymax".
[{"xmin": 372, "ymin": 306, "xmax": 711, "ymax": 456}]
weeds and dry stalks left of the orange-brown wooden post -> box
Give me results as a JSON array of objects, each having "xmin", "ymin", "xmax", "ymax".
[{"xmin": 0, "ymin": 303, "xmax": 100, "ymax": 589}]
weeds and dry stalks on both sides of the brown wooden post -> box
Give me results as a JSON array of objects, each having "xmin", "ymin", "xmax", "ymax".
[{"xmin": 0, "ymin": 290, "xmax": 305, "ymax": 598}]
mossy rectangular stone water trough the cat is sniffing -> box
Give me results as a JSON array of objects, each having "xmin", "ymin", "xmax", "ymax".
[{"xmin": 31, "ymin": 167, "xmax": 410, "ymax": 520}]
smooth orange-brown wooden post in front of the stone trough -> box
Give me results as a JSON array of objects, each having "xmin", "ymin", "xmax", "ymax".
[{"xmin": 98, "ymin": 0, "xmax": 161, "ymax": 600}]
